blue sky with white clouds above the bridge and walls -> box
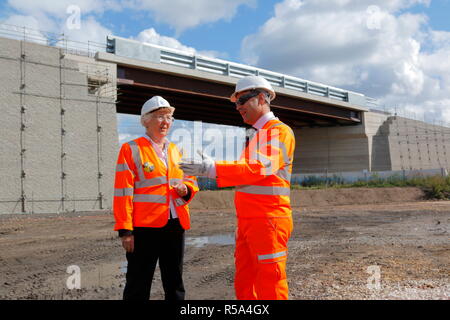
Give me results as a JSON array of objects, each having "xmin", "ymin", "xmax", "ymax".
[{"xmin": 0, "ymin": 0, "xmax": 450, "ymax": 148}]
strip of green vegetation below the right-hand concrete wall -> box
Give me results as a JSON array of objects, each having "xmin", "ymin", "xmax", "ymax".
[{"xmin": 292, "ymin": 175, "xmax": 450, "ymax": 200}]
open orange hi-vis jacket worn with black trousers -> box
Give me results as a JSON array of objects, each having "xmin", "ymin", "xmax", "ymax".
[{"xmin": 113, "ymin": 137, "xmax": 199, "ymax": 230}]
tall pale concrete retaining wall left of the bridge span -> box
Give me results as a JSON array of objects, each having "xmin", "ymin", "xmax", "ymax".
[{"xmin": 0, "ymin": 38, "xmax": 118, "ymax": 213}]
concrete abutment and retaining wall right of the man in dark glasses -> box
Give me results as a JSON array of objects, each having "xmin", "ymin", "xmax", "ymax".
[{"xmin": 293, "ymin": 112, "xmax": 450, "ymax": 174}]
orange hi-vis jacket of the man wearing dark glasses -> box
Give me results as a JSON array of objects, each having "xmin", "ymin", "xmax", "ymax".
[{"xmin": 216, "ymin": 119, "xmax": 295, "ymax": 218}]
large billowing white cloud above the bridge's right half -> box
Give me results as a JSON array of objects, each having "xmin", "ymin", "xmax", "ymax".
[{"xmin": 241, "ymin": 0, "xmax": 450, "ymax": 122}]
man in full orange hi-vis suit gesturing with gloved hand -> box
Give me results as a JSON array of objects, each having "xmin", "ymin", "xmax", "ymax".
[{"xmin": 180, "ymin": 76, "xmax": 295, "ymax": 300}]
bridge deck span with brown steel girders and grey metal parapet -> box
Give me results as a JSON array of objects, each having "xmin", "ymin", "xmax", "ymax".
[{"xmin": 104, "ymin": 37, "xmax": 367, "ymax": 128}]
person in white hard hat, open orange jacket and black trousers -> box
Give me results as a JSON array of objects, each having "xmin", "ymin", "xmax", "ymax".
[{"xmin": 114, "ymin": 96, "xmax": 198, "ymax": 300}]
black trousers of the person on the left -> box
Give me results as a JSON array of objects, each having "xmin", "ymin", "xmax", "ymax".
[{"xmin": 123, "ymin": 219, "xmax": 185, "ymax": 300}]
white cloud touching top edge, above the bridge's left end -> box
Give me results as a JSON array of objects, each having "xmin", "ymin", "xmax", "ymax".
[{"xmin": 130, "ymin": 0, "xmax": 256, "ymax": 34}]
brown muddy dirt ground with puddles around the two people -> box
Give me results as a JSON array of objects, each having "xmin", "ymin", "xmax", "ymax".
[{"xmin": 0, "ymin": 189, "xmax": 450, "ymax": 300}]
